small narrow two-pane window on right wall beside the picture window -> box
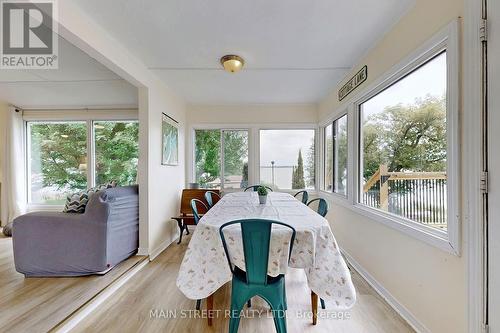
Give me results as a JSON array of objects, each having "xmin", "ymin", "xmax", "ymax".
[{"xmin": 324, "ymin": 115, "xmax": 348, "ymax": 196}]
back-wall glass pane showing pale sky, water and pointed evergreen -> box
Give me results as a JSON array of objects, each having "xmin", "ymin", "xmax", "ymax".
[{"xmin": 260, "ymin": 130, "xmax": 315, "ymax": 189}]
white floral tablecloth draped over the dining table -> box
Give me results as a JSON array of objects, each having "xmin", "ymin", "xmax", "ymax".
[{"xmin": 177, "ymin": 192, "xmax": 356, "ymax": 310}]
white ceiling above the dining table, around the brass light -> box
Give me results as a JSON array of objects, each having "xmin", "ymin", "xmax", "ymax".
[{"xmin": 71, "ymin": 0, "xmax": 415, "ymax": 104}]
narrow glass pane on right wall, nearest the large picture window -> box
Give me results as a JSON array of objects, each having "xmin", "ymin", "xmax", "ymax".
[{"xmin": 333, "ymin": 115, "xmax": 347, "ymax": 195}]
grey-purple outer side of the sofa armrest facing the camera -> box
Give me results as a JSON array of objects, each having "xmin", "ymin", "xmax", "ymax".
[{"xmin": 12, "ymin": 212, "xmax": 107, "ymax": 276}]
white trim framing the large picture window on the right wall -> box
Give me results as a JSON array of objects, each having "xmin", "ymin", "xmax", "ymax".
[{"xmin": 321, "ymin": 20, "xmax": 461, "ymax": 256}]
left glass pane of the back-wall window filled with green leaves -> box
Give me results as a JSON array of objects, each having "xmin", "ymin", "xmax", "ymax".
[{"xmin": 195, "ymin": 130, "xmax": 221, "ymax": 188}]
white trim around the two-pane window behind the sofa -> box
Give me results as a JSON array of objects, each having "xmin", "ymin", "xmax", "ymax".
[{"xmin": 23, "ymin": 108, "xmax": 139, "ymax": 212}]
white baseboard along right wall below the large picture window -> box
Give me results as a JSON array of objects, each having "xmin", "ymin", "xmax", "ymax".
[{"xmin": 341, "ymin": 249, "xmax": 431, "ymax": 333}]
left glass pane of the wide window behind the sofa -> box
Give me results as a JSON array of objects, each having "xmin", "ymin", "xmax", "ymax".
[{"xmin": 28, "ymin": 122, "xmax": 87, "ymax": 204}]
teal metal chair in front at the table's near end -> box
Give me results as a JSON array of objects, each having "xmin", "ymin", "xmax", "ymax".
[{"xmin": 219, "ymin": 219, "xmax": 295, "ymax": 333}]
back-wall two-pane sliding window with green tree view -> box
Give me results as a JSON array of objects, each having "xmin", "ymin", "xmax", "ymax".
[{"xmin": 195, "ymin": 129, "xmax": 248, "ymax": 188}]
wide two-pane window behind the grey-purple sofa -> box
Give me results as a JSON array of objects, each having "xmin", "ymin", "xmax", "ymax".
[{"xmin": 27, "ymin": 121, "xmax": 138, "ymax": 205}]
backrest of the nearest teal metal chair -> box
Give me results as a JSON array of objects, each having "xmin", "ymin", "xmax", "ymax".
[{"xmin": 219, "ymin": 219, "xmax": 295, "ymax": 285}]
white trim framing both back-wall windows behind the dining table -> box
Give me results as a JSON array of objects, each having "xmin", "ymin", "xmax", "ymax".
[{"xmin": 186, "ymin": 123, "xmax": 320, "ymax": 195}]
